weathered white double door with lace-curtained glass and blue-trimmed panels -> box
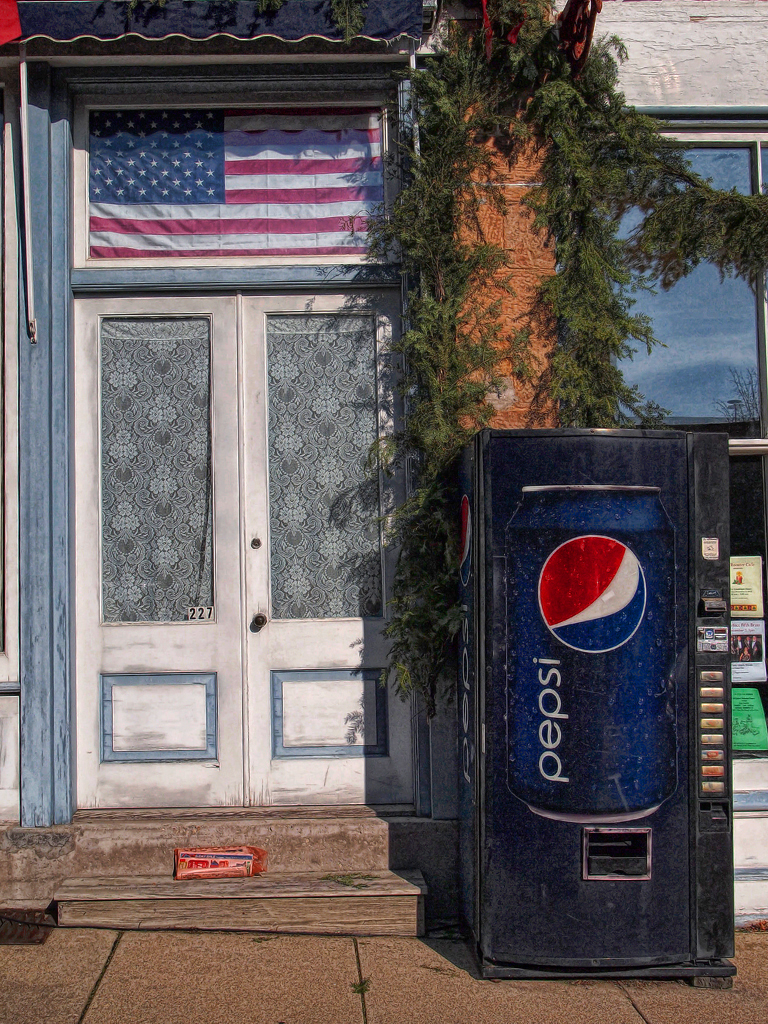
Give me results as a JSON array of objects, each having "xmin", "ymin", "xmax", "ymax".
[{"xmin": 74, "ymin": 294, "xmax": 413, "ymax": 808}]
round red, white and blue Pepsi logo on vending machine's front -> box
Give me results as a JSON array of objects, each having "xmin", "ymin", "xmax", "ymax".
[{"xmin": 539, "ymin": 535, "xmax": 646, "ymax": 654}]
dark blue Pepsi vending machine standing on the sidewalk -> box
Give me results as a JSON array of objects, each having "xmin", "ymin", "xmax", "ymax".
[{"xmin": 459, "ymin": 430, "xmax": 735, "ymax": 984}]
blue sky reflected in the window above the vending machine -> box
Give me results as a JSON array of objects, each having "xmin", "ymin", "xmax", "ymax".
[{"xmin": 622, "ymin": 147, "xmax": 757, "ymax": 423}]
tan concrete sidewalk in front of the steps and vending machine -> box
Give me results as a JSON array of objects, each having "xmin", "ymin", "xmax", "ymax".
[{"xmin": 0, "ymin": 929, "xmax": 768, "ymax": 1024}]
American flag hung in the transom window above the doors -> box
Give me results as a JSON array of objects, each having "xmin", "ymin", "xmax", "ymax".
[{"xmin": 89, "ymin": 108, "xmax": 384, "ymax": 258}]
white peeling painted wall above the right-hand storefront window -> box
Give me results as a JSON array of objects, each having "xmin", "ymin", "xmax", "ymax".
[{"xmin": 595, "ymin": 0, "xmax": 768, "ymax": 113}]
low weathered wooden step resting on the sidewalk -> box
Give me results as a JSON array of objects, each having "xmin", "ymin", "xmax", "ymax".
[{"xmin": 54, "ymin": 871, "xmax": 424, "ymax": 935}]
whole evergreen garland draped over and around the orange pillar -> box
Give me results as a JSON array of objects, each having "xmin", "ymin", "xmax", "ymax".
[{"xmin": 371, "ymin": 0, "xmax": 768, "ymax": 714}]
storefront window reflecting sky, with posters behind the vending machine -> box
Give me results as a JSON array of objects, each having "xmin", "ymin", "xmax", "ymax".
[{"xmin": 622, "ymin": 140, "xmax": 768, "ymax": 758}]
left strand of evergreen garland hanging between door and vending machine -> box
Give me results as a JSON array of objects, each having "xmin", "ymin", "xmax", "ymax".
[{"xmin": 369, "ymin": 34, "xmax": 527, "ymax": 714}]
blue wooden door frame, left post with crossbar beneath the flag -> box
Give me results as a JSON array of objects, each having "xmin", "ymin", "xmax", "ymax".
[{"xmin": 18, "ymin": 60, "xmax": 400, "ymax": 827}]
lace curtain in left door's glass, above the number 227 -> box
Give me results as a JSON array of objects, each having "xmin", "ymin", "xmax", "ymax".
[{"xmin": 100, "ymin": 316, "xmax": 213, "ymax": 623}]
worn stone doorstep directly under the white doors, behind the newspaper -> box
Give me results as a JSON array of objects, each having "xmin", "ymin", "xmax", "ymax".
[{"xmin": 0, "ymin": 807, "xmax": 397, "ymax": 905}]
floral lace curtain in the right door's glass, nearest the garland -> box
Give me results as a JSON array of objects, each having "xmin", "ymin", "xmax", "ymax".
[{"xmin": 266, "ymin": 314, "xmax": 382, "ymax": 618}]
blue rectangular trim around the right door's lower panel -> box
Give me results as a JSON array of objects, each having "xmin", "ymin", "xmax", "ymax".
[{"xmin": 271, "ymin": 669, "xmax": 389, "ymax": 758}]
